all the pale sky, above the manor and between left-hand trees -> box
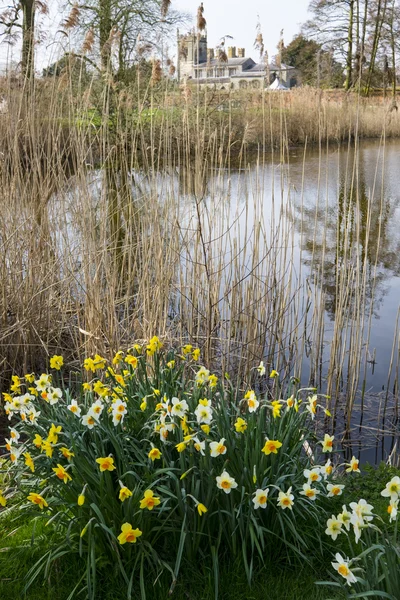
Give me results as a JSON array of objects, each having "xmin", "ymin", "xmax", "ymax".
[{"xmin": 0, "ymin": 0, "xmax": 309, "ymax": 71}]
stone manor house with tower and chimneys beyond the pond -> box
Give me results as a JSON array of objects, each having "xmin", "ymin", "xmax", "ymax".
[{"xmin": 177, "ymin": 30, "xmax": 300, "ymax": 89}]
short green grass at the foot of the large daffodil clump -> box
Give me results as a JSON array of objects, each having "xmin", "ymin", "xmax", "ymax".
[{"xmin": 0, "ymin": 513, "xmax": 343, "ymax": 600}]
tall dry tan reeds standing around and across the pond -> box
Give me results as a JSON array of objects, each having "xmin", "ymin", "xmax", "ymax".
[{"xmin": 0, "ymin": 74, "xmax": 400, "ymax": 446}]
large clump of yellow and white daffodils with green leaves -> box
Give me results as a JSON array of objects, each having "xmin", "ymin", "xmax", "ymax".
[{"xmin": 0, "ymin": 337, "xmax": 342, "ymax": 599}]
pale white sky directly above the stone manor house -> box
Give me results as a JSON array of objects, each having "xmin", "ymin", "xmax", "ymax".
[{"xmin": 172, "ymin": 0, "xmax": 309, "ymax": 60}]
